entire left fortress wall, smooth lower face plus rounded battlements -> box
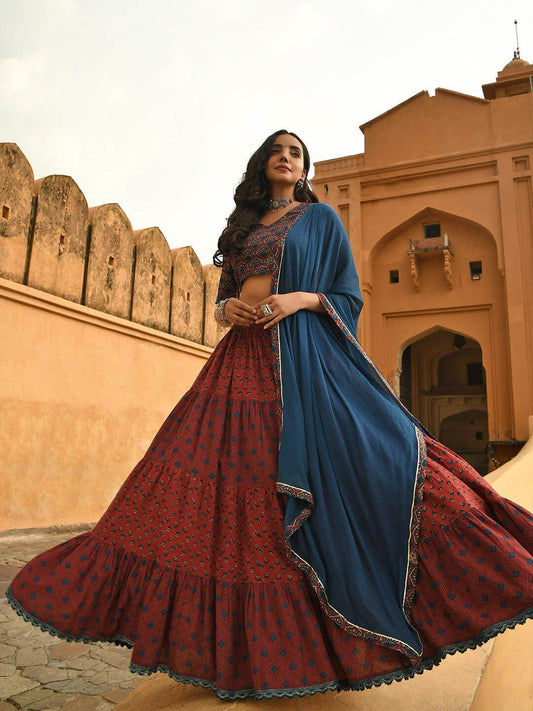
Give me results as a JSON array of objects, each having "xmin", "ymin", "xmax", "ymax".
[{"xmin": 0, "ymin": 143, "xmax": 225, "ymax": 530}]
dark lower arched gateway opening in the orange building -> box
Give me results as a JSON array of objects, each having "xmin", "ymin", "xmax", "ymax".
[{"xmin": 400, "ymin": 328, "xmax": 489, "ymax": 474}]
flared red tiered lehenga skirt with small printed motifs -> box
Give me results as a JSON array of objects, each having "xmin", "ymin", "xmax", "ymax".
[{"xmin": 7, "ymin": 326, "xmax": 533, "ymax": 698}]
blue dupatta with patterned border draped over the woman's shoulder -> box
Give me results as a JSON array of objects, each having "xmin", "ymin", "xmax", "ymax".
[{"xmin": 273, "ymin": 203, "xmax": 425, "ymax": 664}]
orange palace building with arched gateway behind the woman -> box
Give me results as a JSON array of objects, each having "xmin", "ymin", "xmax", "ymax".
[{"xmin": 313, "ymin": 56, "xmax": 533, "ymax": 472}]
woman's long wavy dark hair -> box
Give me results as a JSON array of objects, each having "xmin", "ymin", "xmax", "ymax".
[{"xmin": 213, "ymin": 129, "xmax": 319, "ymax": 267}]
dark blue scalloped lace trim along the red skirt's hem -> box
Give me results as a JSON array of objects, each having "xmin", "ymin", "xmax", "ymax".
[{"xmin": 6, "ymin": 588, "xmax": 533, "ymax": 700}]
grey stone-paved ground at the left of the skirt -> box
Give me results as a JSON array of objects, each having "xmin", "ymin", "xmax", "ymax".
[{"xmin": 0, "ymin": 526, "xmax": 143, "ymax": 711}]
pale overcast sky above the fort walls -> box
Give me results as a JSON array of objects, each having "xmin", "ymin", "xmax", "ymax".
[{"xmin": 0, "ymin": 0, "xmax": 533, "ymax": 264}]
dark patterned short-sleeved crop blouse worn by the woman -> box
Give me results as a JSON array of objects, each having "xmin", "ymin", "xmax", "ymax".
[{"xmin": 216, "ymin": 202, "xmax": 309, "ymax": 304}]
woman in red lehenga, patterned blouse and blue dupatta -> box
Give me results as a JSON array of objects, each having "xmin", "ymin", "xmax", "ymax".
[{"xmin": 8, "ymin": 131, "xmax": 533, "ymax": 699}]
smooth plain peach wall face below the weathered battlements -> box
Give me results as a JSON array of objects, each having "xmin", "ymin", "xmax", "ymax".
[{"xmin": 0, "ymin": 279, "xmax": 211, "ymax": 530}]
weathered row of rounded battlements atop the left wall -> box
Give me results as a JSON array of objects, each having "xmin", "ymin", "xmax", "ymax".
[{"xmin": 0, "ymin": 143, "xmax": 225, "ymax": 346}]
